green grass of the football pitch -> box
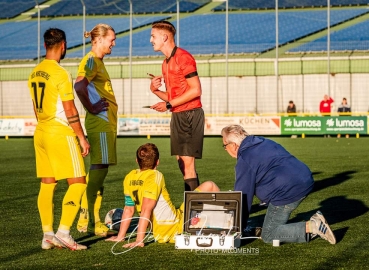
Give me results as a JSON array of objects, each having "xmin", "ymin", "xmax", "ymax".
[{"xmin": 0, "ymin": 137, "xmax": 369, "ymax": 270}]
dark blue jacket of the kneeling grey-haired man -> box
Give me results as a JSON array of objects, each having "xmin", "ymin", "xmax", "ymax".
[{"xmin": 234, "ymin": 136, "xmax": 314, "ymax": 213}]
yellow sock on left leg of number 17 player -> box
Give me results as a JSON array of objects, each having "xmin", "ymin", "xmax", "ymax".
[{"xmin": 37, "ymin": 183, "xmax": 56, "ymax": 233}]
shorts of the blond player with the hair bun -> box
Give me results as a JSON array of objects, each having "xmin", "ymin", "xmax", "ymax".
[{"xmin": 88, "ymin": 132, "xmax": 117, "ymax": 165}]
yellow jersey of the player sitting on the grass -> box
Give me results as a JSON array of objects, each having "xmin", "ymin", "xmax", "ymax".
[{"xmin": 123, "ymin": 169, "xmax": 183, "ymax": 243}]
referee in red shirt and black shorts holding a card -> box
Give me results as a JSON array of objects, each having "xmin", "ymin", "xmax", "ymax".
[{"xmin": 149, "ymin": 21, "xmax": 205, "ymax": 191}]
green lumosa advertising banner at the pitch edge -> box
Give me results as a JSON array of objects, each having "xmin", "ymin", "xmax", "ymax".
[{"xmin": 281, "ymin": 116, "xmax": 368, "ymax": 135}]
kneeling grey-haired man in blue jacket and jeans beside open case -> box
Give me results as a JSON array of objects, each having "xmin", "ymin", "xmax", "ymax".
[{"xmin": 222, "ymin": 125, "xmax": 336, "ymax": 244}]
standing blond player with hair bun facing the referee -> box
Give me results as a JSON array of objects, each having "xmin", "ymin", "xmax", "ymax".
[{"xmin": 74, "ymin": 24, "xmax": 118, "ymax": 236}]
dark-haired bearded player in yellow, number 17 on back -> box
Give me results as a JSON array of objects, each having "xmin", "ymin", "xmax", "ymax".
[{"xmin": 28, "ymin": 28, "xmax": 90, "ymax": 250}]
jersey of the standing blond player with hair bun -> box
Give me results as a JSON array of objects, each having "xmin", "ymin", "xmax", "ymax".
[{"xmin": 77, "ymin": 52, "xmax": 118, "ymax": 133}]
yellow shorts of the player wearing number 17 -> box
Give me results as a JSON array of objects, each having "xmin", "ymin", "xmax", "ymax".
[{"xmin": 34, "ymin": 129, "xmax": 86, "ymax": 180}]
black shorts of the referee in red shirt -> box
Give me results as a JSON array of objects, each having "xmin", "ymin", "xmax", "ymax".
[{"xmin": 170, "ymin": 108, "xmax": 205, "ymax": 158}]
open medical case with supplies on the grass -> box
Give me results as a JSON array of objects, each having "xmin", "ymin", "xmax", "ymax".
[{"xmin": 175, "ymin": 191, "xmax": 242, "ymax": 249}]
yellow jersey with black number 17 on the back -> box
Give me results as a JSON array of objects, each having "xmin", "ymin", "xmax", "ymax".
[{"xmin": 28, "ymin": 59, "xmax": 75, "ymax": 135}]
